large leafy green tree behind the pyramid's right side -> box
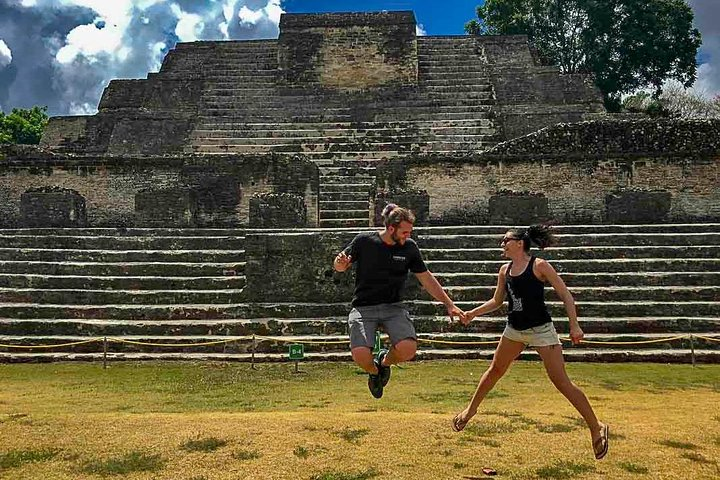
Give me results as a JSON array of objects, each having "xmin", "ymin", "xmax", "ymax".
[{"xmin": 465, "ymin": 0, "xmax": 701, "ymax": 110}]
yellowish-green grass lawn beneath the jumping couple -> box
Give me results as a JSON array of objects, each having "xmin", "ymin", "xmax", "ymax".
[{"xmin": 0, "ymin": 361, "xmax": 720, "ymax": 480}]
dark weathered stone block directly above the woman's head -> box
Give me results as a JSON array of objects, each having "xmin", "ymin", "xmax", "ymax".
[{"xmin": 488, "ymin": 192, "xmax": 548, "ymax": 225}]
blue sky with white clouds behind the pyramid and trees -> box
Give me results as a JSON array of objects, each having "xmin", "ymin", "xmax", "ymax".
[{"xmin": 0, "ymin": 0, "xmax": 720, "ymax": 115}]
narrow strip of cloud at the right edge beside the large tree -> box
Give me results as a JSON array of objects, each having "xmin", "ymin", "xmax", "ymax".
[{"xmin": 689, "ymin": 0, "xmax": 720, "ymax": 96}]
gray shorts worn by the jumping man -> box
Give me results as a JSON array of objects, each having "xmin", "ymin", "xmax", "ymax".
[{"xmin": 348, "ymin": 303, "xmax": 417, "ymax": 348}]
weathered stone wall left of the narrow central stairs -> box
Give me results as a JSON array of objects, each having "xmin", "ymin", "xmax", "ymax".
[{"xmin": 0, "ymin": 149, "xmax": 319, "ymax": 227}]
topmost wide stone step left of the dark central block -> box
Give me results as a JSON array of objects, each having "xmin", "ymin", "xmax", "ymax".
[{"xmin": 0, "ymin": 231, "xmax": 245, "ymax": 251}]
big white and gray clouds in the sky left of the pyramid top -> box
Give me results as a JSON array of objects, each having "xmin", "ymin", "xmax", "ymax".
[{"xmin": 0, "ymin": 0, "xmax": 283, "ymax": 115}]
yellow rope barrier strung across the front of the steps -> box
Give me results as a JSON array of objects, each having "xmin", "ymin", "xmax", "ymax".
[{"xmin": 0, "ymin": 333, "xmax": 720, "ymax": 350}]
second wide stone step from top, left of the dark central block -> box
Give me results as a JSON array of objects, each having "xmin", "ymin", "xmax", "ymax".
[{"xmin": 0, "ymin": 247, "xmax": 245, "ymax": 263}]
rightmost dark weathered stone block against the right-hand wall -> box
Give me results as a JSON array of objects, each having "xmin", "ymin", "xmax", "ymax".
[{"xmin": 605, "ymin": 190, "xmax": 672, "ymax": 223}]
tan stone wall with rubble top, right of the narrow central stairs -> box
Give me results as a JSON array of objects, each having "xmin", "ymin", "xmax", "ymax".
[{"xmin": 378, "ymin": 121, "xmax": 720, "ymax": 224}]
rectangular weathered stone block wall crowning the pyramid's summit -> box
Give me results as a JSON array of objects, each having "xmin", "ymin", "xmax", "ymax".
[{"xmin": 278, "ymin": 12, "xmax": 417, "ymax": 91}]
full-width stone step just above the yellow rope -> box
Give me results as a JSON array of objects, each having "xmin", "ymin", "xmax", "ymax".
[{"xmin": 0, "ymin": 315, "xmax": 720, "ymax": 337}]
